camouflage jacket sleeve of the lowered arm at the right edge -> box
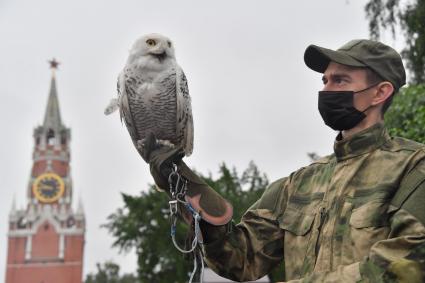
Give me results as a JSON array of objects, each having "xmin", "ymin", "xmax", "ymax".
[{"xmin": 282, "ymin": 166, "xmax": 425, "ymax": 283}]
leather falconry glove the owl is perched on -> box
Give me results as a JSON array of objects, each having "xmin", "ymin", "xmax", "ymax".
[{"xmin": 141, "ymin": 134, "xmax": 233, "ymax": 226}]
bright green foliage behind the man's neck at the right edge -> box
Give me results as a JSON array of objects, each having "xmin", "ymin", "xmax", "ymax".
[{"xmin": 385, "ymin": 84, "xmax": 425, "ymax": 143}]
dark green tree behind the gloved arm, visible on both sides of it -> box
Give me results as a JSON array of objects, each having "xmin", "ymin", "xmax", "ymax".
[{"xmin": 104, "ymin": 162, "xmax": 283, "ymax": 283}]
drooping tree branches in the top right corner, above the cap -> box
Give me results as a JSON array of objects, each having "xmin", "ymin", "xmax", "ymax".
[{"xmin": 365, "ymin": 0, "xmax": 425, "ymax": 84}]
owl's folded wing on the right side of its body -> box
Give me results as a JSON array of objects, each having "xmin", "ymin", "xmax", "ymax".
[{"xmin": 176, "ymin": 65, "xmax": 193, "ymax": 156}]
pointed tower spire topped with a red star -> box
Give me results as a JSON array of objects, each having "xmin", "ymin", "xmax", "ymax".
[{"xmin": 43, "ymin": 58, "xmax": 62, "ymax": 130}]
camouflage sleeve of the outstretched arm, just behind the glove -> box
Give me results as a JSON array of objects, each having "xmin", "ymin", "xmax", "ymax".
[{"xmin": 201, "ymin": 178, "xmax": 287, "ymax": 281}]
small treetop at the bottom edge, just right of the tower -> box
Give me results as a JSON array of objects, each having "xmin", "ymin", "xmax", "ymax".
[{"xmin": 84, "ymin": 261, "xmax": 138, "ymax": 283}]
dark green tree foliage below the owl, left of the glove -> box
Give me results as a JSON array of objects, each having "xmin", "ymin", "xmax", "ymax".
[{"xmin": 105, "ymin": 186, "xmax": 189, "ymax": 282}]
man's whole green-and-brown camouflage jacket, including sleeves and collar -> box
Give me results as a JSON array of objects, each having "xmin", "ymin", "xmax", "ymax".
[{"xmin": 203, "ymin": 124, "xmax": 425, "ymax": 282}]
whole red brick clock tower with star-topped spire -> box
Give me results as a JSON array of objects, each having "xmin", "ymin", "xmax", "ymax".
[{"xmin": 6, "ymin": 59, "xmax": 85, "ymax": 283}]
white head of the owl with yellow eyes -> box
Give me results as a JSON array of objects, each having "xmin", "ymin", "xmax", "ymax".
[{"xmin": 130, "ymin": 33, "xmax": 175, "ymax": 62}]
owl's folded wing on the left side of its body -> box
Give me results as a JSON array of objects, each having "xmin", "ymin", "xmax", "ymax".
[{"xmin": 117, "ymin": 69, "xmax": 139, "ymax": 151}]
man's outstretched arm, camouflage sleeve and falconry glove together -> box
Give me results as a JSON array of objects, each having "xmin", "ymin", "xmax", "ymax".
[{"xmin": 143, "ymin": 139, "xmax": 290, "ymax": 281}]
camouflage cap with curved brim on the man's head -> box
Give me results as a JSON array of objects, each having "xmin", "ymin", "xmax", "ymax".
[{"xmin": 304, "ymin": 39, "xmax": 406, "ymax": 89}]
